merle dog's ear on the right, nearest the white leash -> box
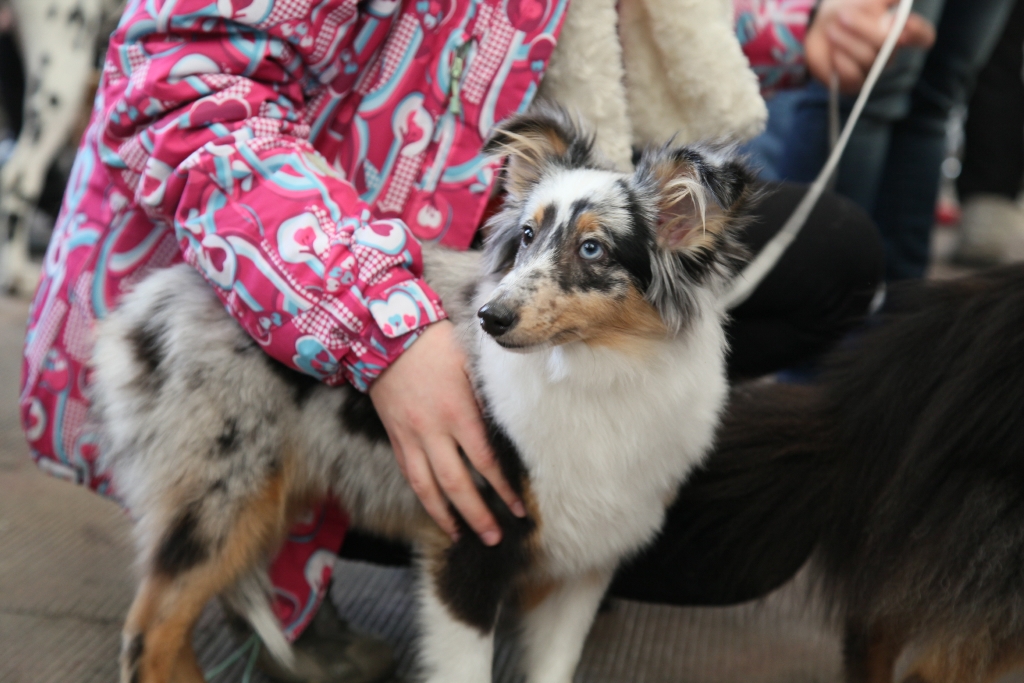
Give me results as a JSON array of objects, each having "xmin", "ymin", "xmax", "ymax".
[{"xmin": 636, "ymin": 147, "xmax": 754, "ymax": 252}]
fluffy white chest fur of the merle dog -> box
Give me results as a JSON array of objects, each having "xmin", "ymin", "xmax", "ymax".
[{"xmin": 478, "ymin": 306, "xmax": 727, "ymax": 577}]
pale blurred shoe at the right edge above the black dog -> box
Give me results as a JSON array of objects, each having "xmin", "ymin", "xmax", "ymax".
[{"xmin": 952, "ymin": 195, "xmax": 1024, "ymax": 267}]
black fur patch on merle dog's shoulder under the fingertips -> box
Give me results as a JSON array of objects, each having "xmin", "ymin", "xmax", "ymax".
[{"xmin": 436, "ymin": 419, "xmax": 537, "ymax": 633}]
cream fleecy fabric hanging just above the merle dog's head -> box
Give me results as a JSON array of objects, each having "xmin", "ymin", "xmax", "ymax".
[{"xmin": 540, "ymin": 0, "xmax": 768, "ymax": 169}]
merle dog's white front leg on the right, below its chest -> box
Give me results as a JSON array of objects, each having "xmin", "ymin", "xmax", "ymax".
[{"xmin": 522, "ymin": 570, "xmax": 612, "ymax": 683}]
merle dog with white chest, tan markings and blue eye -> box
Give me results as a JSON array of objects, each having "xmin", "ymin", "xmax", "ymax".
[{"xmin": 94, "ymin": 111, "xmax": 751, "ymax": 683}]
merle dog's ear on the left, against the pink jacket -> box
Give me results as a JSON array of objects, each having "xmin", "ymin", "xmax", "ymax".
[{"xmin": 483, "ymin": 104, "xmax": 594, "ymax": 199}]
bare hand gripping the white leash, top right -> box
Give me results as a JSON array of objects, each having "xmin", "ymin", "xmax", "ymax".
[{"xmin": 805, "ymin": 0, "xmax": 935, "ymax": 94}]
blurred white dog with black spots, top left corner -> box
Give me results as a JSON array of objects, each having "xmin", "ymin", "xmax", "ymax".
[{"xmin": 0, "ymin": 0, "xmax": 123, "ymax": 294}]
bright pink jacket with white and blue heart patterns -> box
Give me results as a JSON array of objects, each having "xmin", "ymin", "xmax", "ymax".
[{"xmin": 20, "ymin": 0, "xmax": 811, "ymax": 636}]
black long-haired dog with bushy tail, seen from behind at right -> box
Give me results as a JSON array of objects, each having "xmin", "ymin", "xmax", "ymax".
[{"xmin": 673, "ymin": 266, "xmax": 1024, "ymax": 683}]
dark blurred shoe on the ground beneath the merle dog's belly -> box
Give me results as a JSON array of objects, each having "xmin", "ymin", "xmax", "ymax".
[{"xmin": 257, "ymin": 599, "xmax": 395, "ymax": 683}]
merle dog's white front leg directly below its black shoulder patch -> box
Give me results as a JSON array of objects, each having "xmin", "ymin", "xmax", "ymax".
[{"xmin": 420, "ymin": 571, "xmax": 495, "ymax": 683}]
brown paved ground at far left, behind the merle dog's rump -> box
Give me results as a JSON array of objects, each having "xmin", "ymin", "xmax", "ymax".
[{"xmin": 0, "ymin": 298, "xmax": 131, "ymax": 683}]
